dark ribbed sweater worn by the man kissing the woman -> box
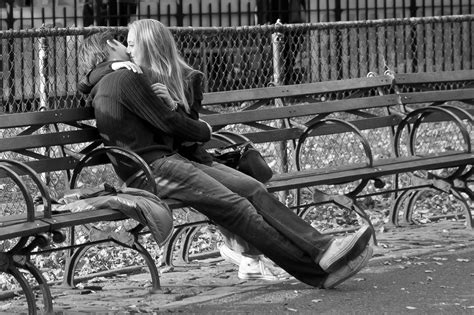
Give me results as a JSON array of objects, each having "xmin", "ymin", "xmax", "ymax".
[{"xmin": 80, "ymin": 62, "xmax": 211, "ymax": 179}]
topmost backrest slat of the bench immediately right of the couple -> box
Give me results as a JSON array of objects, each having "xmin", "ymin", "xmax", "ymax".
[{"xmin": 203, "ymin": 75, "xmax": 392, "ymax": 106}]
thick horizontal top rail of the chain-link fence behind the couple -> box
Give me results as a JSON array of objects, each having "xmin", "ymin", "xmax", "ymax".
[{"xmin": 0, "ymin": 14, "xmax": 474, "ymax": 39}]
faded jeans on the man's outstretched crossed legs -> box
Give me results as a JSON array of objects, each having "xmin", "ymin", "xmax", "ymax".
[{"xmin": 151, "ymin": 154, "xmax": 332, "ymax": 287}]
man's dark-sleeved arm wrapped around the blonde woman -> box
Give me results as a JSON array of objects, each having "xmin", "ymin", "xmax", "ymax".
[{"xmin": 116, "ymin": 70, "xmax": 211, "ymax": 142}]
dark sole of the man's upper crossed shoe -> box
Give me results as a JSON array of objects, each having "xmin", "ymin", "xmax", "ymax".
[{"xmin": 319, "ymin": 225, "xmax": 372, "ymax": 273}]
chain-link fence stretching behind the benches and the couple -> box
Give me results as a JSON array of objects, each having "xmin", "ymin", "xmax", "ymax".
[{"xmin": 0, "ymin": 15, "xmax": 474, "ymax": 112}]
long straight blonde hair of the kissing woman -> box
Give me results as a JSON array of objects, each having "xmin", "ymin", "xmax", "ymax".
[{"xmin": 129, "ymin": 19, "xmax": 199, "ymax": 113}]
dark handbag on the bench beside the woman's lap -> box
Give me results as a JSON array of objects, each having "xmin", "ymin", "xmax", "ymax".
[{"xmin": 211, "ymin": 132, "xmax": 273, "ymax": 183}]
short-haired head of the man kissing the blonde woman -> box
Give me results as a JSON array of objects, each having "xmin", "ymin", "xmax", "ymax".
[{"xmin": 79, "ymin": 31, "xmax": 130, "ymax": 74}]
